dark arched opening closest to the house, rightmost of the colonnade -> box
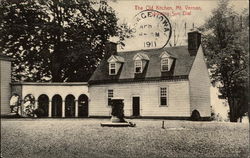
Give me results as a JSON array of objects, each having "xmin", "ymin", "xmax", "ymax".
[{"xmin": 78, "ymin": 94, "xmax": 89, "ymax": 117}]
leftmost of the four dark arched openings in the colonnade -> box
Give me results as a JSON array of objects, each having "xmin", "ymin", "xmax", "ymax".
[{"xmin": 38, "ymin": 94, "xmax": 49, "ymax": 117}]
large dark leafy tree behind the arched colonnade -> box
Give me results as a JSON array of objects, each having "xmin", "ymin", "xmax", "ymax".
[{"xmin": 0, "ymin": 0, "xmax": 119, "ymax": 82}]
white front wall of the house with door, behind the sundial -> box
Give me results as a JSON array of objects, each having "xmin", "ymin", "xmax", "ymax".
[{"xmin": 89, "ymin": 80, "xmax": 190, "ymax": 117}]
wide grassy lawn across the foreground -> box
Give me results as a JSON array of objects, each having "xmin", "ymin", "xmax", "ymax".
[{"xmin": 1, "ymin": 119, "xmax": 249, "ymax": 158}]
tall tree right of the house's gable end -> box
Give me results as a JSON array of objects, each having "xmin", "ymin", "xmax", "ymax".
[{"xmin": 202, "ymin": 0, "xmax": 249, "ymax": 122}]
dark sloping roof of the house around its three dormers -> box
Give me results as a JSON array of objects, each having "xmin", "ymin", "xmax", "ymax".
[{"xmin": 89, "ymin": 46, "xmax": 195, "ymax": 84}]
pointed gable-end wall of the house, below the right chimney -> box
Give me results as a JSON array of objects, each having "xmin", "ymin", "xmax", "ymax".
[{"xmin": 189, "ymin": 47, "xmax": 211, "ymax": 117}]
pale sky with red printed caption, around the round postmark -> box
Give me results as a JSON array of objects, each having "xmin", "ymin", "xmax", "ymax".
[{"xmin": 109, "ymin": 0, "xmax": 249, "ymax": 51}]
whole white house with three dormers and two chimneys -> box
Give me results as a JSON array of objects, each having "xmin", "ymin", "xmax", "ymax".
[{"xmin": 89, "ymin": 31, "xmax": 211, "ymax": 118}]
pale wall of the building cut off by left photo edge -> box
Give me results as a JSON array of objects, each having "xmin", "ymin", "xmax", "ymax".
[{"xmin": 0, "ymin": 60, "xmax": 11, "ymax": 115}]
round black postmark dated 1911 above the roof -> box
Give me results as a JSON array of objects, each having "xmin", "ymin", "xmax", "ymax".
[{"xmin": 133, "ymin": 10, "xmax": 172, "ymax": 50}]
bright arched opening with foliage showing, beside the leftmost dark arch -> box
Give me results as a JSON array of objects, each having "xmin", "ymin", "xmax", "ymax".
[{"xmin": 22, "ymin": 94, "xmax": 35, "ymax": 116}]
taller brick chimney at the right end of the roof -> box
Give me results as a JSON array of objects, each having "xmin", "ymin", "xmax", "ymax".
[{"xmin": 188, "ymin": 31, "xmax": 201, "ymax": 56}]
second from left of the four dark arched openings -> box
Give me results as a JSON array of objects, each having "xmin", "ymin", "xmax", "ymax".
[{"xmin": 52, "ymin": 94, "xmax": 62, "ymax": 117}]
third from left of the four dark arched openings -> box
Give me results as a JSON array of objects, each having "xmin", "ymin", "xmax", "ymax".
[{"xmin": 65, "ymin": 94, "xmax": 75, "ymax": 117}]
